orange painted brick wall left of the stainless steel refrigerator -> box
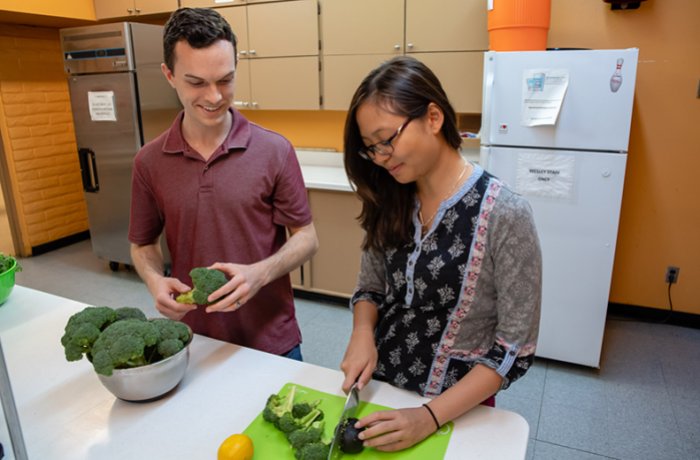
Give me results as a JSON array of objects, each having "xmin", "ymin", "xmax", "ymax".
[{"xmin": 0, "ymin": 24, "xmax": 88, "ymax": 255}]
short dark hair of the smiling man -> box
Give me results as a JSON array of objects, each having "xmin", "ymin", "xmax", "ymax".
[{"xmin": 163, "ymin": 8, "xmax": 238, "ymax": 72}]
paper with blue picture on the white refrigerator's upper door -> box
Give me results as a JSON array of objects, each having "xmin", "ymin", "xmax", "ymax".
[{"xmin": 520, "ymin": 69, "xmax": 569, "ymax": 126}]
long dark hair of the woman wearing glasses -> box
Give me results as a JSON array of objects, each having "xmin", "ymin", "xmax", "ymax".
[{"xmin": 344, "ymin": 56, "xmax": 462, "ymax": 250}]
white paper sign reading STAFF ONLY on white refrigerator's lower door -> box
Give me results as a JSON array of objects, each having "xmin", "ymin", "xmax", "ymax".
[{"xmin": 515, "ymin": 153, "xmax": 575, "ymax": 200}]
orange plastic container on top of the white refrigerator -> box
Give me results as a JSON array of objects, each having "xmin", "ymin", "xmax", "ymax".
[{"xmin": 488, "ymin": 0, "xmax": 551, "ymax": 51}]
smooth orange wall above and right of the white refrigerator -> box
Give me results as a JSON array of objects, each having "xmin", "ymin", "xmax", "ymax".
[{"xmin": 548, "ymin": 0, "xmax": 700, "ymax": 314}]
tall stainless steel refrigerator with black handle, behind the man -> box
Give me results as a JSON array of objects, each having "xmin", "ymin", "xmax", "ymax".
[{"xmin": 60, "ymin": 22, "xmax": 181, "ymax": 270}]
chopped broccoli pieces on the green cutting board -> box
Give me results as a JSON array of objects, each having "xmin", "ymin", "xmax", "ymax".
[{"xmin": 262, "ymin": 386, "xmax": 329, "ymax": 460}]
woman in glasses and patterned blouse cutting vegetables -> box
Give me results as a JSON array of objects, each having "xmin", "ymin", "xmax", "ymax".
[{"xmin": 341, "ymin": 56, "xmax": 541, "ymax": 451}]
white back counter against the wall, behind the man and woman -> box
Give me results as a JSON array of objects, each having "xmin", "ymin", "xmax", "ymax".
[{"xmin": 296, "ymin": 148, "xmax": 479, "ymax": 192}]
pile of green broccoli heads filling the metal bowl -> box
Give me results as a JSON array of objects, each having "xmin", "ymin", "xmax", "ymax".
[{"xmin": 61, "ymin": 307, "xmax": 191, "ymax": 376}]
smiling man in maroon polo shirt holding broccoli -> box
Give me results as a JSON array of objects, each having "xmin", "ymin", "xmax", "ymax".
[{"xmin": 129, "ymin": 8, "xmax": 318, "ymax": 360}]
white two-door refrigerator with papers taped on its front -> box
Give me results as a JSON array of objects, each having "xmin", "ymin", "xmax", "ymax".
[{"xmin": 480, "ymin": 48, "xmax": 638, "ymax": 367}]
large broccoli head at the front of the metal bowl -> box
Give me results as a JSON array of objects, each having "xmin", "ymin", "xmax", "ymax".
[{"xmin": 92, "ymin": 319, "xmax": 159, "ymax": 376}]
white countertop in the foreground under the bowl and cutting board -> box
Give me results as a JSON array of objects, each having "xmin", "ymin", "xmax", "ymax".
[{"xmin": 0, "ymin": 286, "xmax": 529, "ymax": 460}]
